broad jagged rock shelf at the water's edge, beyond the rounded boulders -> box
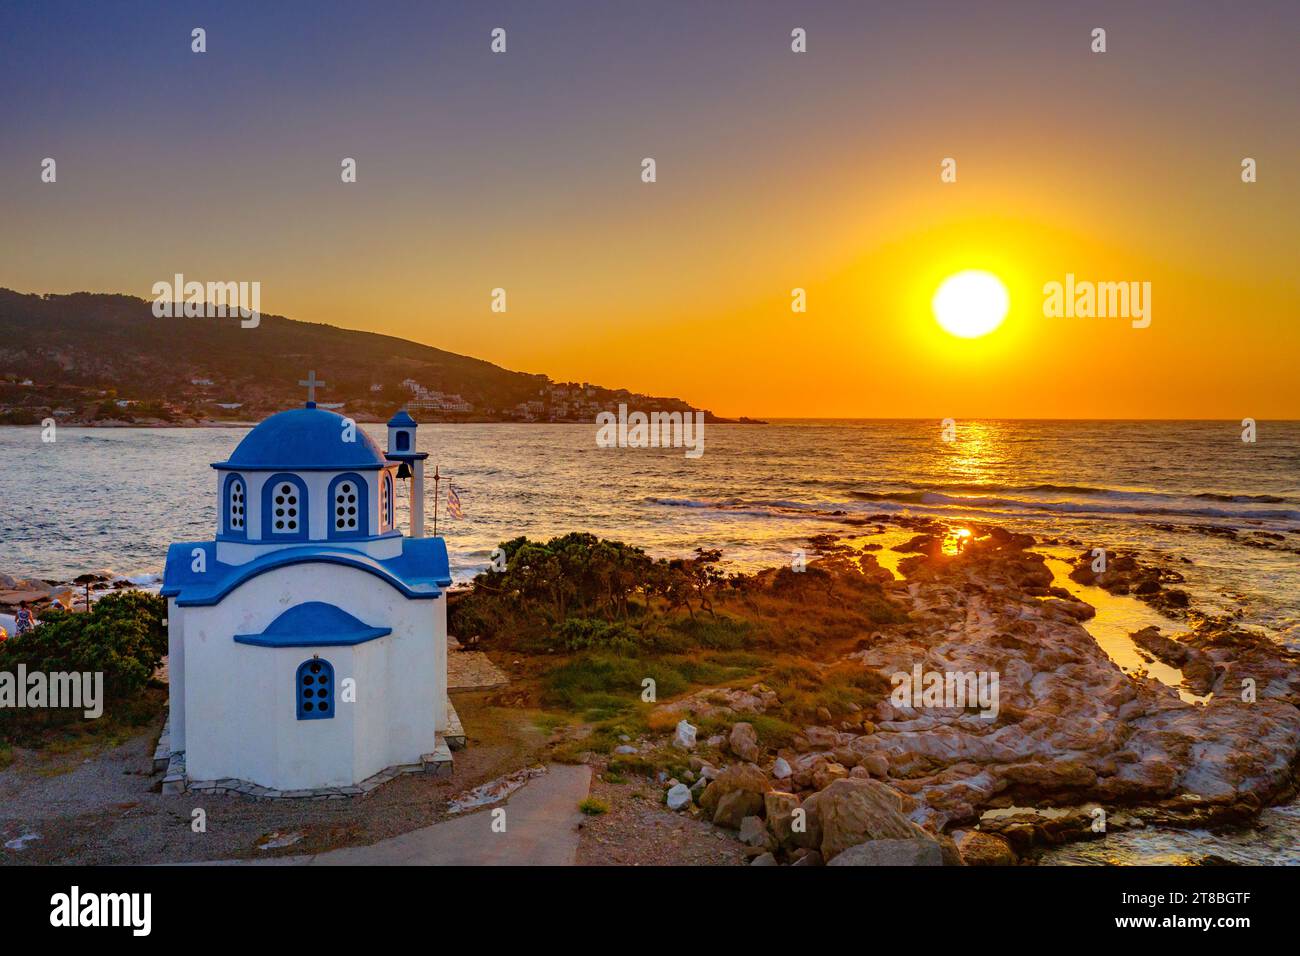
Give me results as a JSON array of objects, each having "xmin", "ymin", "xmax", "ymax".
[{"xmin": 852, "ymin": 535, "xmax": 1300, "ymax": 839}]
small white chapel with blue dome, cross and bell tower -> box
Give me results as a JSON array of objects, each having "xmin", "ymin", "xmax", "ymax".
[{"xmin": 163, "ymin": 373, "xmax": 459, "ymax": 796}]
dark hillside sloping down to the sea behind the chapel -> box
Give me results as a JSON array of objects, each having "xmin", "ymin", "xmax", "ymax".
[{"xmin": 0, "ymin": 289, "xmax": 743, "ymax": 424}]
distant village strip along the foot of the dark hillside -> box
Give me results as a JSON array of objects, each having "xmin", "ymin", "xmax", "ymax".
[{"xmin": 0, "ymin": 372, "xmax": 743, "ymax": 425}]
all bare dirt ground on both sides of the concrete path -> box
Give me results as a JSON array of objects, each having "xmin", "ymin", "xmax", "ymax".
[{"xmin": 0, "ymin": 691, "xmax": 744, "ymax": 866}]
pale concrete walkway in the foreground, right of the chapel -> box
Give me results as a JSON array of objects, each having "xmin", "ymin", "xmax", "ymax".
[{"xmin": 198, "ymin": 763, "xmax": 592, "ymax": 866}]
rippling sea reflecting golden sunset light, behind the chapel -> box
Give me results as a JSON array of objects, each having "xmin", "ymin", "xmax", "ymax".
[{"xmin": 0, "ymin": 420, "xmax": 1300, "ymax": 862}]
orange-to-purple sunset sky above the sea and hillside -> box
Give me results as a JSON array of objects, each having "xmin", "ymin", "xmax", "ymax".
[{"xmin": 0, "ymin": 3, "xmax": 1300, "ymax": 419}]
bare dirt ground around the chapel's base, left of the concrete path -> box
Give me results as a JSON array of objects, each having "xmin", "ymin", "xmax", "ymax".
[{"xmin": 0, "ymin": 692, "xmax": 550, "ymax": 865}]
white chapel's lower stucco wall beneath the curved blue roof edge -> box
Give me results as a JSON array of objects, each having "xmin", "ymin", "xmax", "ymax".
[{"xmin": 172, "ymin": 563, "xmax": 447, "ymax": 790}]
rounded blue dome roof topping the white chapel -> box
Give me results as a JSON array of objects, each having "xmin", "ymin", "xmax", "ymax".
[{"xmin": 212, "ymin": 408, "xmax": 387, "ymax": 471}]
